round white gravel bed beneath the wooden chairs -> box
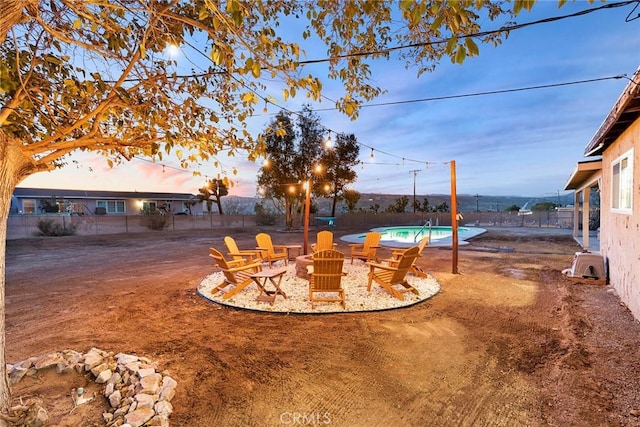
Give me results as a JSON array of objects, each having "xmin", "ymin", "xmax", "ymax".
[{"xmin": 198, "ymin": 261, "xmax": 440, "ymax": 313}]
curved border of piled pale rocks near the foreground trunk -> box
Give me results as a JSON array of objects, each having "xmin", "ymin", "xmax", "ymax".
[{"xmin": 7, "ymin": 348, "xmax": 178, "ymax": 427}]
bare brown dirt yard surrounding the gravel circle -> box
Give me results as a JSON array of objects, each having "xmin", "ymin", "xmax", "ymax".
[{"xmin": 6, "ymin": 229, "xmax": 640, "ymax": 427}]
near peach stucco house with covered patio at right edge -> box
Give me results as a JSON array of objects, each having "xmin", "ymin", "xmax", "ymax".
[{"xmin": 565, "ymin": 68, "xmax": 640, "ymax": 319}]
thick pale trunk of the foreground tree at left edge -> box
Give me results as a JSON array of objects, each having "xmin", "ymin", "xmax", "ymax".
[{"xmin": 0, "ymin": 129, "xmax": 35, "ymax": 426}]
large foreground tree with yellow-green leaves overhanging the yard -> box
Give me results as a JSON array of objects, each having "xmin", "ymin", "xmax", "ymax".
[{"xmin": 0, "ymin": 0, "xmax": 533, "ymax": 416}]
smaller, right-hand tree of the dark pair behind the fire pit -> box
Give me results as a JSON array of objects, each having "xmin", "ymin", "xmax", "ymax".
[{"xmin": 320, "ymin": 134, "xmax": 360, "ymax": 216}]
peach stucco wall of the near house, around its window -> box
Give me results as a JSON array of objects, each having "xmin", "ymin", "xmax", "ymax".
[{"xmin": 600, "ymin": 120, "xmax": 640, "ymax": 319}]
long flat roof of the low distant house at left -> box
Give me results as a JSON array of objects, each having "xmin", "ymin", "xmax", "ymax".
[{"xmin": 13, "ymin": 187, "xmax": 196, "ymax": 200}]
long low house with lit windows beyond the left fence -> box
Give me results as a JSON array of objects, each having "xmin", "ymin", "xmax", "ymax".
[{"xmin": 10, "ymin": 187, "xmax": 203, "ymax": 215}]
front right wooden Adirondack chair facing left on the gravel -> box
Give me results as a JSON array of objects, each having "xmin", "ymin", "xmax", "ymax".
[{"xmin": 367, "ymin": 246, "xmax": 419, "ymax": 300}]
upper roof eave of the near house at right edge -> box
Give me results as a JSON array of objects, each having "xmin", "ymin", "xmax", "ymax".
[{"xmin": 584, "ymin": 67, "xmax": 640, "ymax": 157}]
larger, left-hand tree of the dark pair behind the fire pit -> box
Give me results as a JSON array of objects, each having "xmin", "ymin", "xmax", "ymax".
[{"xmin": 258, "ymin": 106, "xmax": 326, "ymax": 229}]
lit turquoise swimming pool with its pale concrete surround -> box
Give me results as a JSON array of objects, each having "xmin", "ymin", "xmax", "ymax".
[{"xmin": 340, "ymin": 225, "xmax": 487, "ymax": 248}]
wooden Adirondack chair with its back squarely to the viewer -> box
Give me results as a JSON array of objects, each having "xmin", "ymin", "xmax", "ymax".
[{"xmin": 308, "ymin": 249, "xmax": 346, "ymax": 308}]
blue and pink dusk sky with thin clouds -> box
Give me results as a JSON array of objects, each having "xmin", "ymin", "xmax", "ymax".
[{"xmin": 20, "ymin": 1, "xmax": 640, "ymax": 197}]
